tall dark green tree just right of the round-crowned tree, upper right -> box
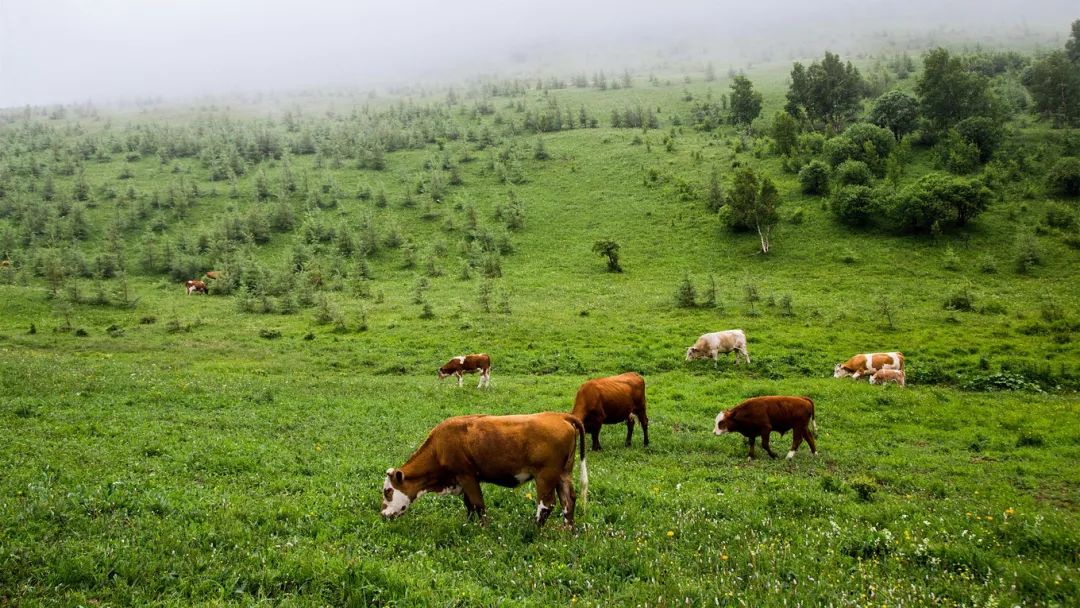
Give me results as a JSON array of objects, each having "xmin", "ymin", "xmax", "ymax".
[{"xmin": 915, "ymin": 49, "xmax": 993, "ymax": 133}]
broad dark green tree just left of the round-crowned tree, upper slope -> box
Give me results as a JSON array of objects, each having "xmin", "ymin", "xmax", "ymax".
[{"xmin": 784, "ymin": 51, "xmax": 866, "ymax": 131}]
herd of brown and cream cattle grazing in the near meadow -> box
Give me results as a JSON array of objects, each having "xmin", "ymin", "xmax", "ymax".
[{"xmin": 382, "ymin": 329, "xmax": 904, "ymax": 526}]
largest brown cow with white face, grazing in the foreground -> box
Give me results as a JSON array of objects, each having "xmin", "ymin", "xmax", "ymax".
[{"xmin": 382, "ymin": 411, "xmax": 589, "ymax": 527}]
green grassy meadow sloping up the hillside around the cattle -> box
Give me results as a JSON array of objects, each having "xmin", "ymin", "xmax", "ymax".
[{"xmin": 0, "ymin": 36, "xmax": 1080, "ymax": 606}]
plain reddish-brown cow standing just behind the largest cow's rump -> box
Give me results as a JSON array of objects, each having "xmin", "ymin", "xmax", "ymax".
[{"xmin": 572, "ymin": 371, "xmax": 649, "ymax": 449}]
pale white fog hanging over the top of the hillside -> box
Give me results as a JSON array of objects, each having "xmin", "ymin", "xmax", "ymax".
[{"xmin": 0, "ymin": 0, "xmax": 1080, "ymax": 107}]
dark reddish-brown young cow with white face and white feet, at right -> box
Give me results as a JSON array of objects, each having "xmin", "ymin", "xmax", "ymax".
[{"xmin": 713, "ymin": 395, "xmax": 818, "ymax": 460}]
